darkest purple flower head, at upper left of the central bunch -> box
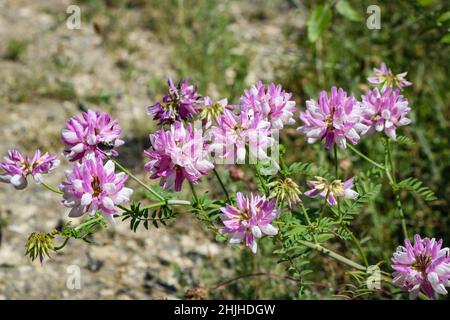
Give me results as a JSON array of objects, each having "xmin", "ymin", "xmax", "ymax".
[{"xmin": 147, "ymin": 79, "xmax": 202, "ymax": 124}]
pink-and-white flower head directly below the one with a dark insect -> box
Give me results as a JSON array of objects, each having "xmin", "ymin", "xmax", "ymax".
[{"xmin": 59, "ymin": 157, "xmax": 133, "ymax": 221}]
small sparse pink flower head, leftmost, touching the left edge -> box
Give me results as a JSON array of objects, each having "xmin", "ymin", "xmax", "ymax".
[{"xmin": 0, "ymin": 149, "xmax": 59, "ymax": 190}]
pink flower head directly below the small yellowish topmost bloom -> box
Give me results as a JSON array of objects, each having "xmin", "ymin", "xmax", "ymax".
[{"xmin": 361, "ymin": 87, "xmax": 411, "ymax": 140}]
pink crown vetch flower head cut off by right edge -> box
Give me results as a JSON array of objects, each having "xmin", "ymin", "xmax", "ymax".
[{"xmin": 392, "ymin": 234, "xmax": 450, "ymax": 299}]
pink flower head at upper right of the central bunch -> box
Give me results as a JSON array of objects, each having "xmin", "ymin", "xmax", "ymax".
[{"xmin": 240, "ymin": 81, "xmax": 296, "ymax": 129}]
